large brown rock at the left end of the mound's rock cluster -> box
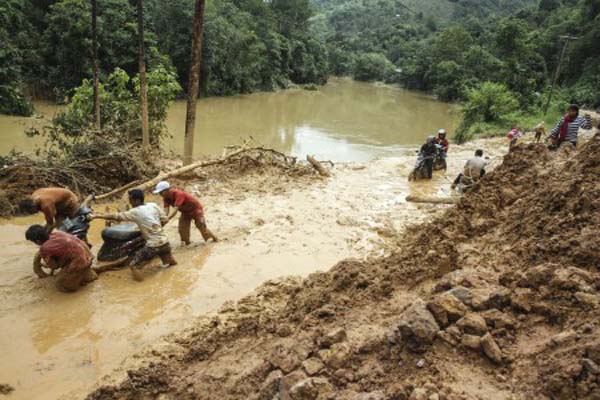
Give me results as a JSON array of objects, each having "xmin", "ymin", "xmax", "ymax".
[{"xmin": 397, "ymin": 300, "xmax": 440, "ymax": 349}]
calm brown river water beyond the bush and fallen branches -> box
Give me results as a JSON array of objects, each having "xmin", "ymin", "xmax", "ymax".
[{"xmin": 0, "ymin": 78, "xmax": 455, "ymax": 161}]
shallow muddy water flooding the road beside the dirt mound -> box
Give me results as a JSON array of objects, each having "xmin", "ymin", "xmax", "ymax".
[{"xmin": 0, "ymin": 141, "xmax": 505, "ymax": 399}]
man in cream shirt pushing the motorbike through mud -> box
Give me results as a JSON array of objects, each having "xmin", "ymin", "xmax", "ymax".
[{"xmin": 92, "ymin": 189, "xmax": 177, "ymax": 281}]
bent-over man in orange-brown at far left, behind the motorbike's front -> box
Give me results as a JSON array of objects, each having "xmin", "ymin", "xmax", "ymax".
[{"xmin": 19, "ymin": 187, "xmax": 79, "ymax": 231}]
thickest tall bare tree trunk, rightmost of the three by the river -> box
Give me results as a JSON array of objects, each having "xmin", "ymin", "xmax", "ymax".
[{"xmin": 183, "ymin": 0, "xmax": 206, "ymax": 165}]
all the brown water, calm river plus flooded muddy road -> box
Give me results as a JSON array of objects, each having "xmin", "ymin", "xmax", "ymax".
[{"xmin": 0, "ymin": 80, "xmax": 474, "ymax": 399}]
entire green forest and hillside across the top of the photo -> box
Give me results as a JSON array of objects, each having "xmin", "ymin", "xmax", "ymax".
[{"xmin": 0, "ymin": 0, "xmax": 600, "ymax": 139}]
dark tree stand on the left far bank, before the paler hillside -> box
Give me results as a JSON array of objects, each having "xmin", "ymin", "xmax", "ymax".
[{"xmin": 0, "ymin": 0, "xmax": 328, "ymax": 115}]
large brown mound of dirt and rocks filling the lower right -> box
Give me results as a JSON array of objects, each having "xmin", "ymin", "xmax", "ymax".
[{"xmin": 88, "ymin": 135, "xmax": 600, "ymax": 400}]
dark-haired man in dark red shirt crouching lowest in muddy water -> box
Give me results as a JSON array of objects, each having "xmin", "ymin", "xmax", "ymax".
[{"xmin": 25, "ymin": 225, "xmax": 98, "ymax": 292}]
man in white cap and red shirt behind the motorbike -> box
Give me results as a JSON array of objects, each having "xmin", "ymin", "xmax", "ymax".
[{"xmin": 154, "ymin": 181, "xmax": 218, "ymax": 245}]
